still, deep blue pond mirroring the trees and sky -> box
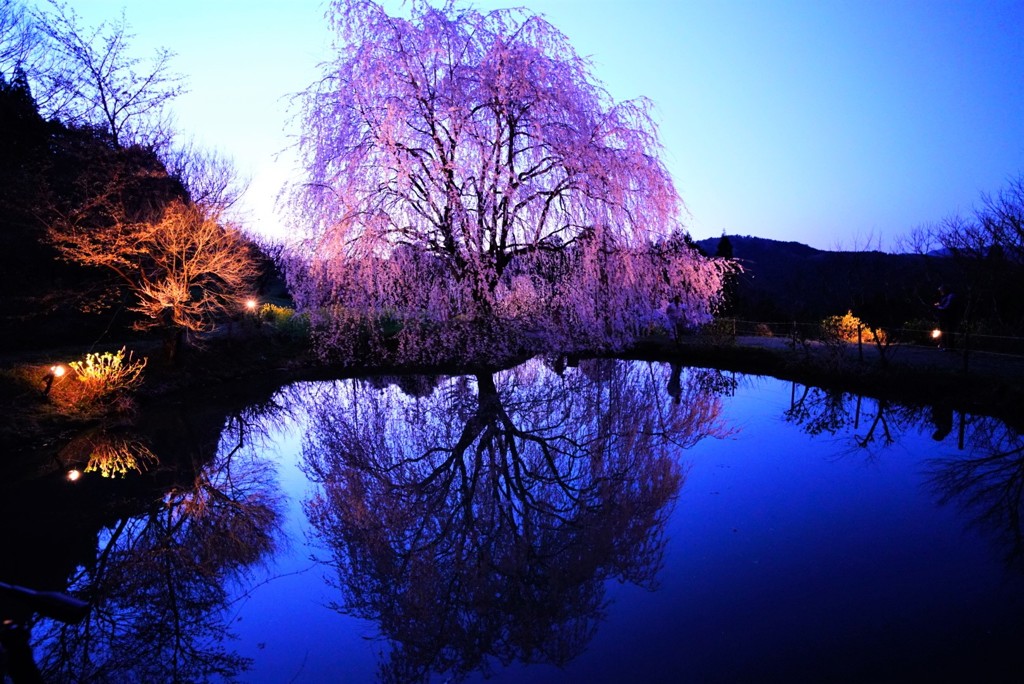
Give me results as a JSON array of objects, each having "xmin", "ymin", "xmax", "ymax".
[{"xmin": 5, "ymin": 358, "xmax": 1024, "ymax": 682}]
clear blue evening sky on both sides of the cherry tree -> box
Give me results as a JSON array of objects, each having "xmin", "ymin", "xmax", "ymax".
[{"xmin": 66, "ymin": 0, "xmax": 1024, "ymax": 249}]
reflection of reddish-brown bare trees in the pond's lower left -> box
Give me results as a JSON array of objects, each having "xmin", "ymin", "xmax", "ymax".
[{"xmin": 35, "ymin": 423, "xmax": 280, "ymax": 682}]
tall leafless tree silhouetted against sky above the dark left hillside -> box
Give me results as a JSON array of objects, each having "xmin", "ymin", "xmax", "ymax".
[{"xmin": 31, "ymin": 0, "xmax": 184, "ymax": 148}]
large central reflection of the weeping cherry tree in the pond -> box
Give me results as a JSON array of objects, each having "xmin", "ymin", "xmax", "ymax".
[{"xmin": 304, "ymin": 360, "xmax": 724, "ymax": 681}]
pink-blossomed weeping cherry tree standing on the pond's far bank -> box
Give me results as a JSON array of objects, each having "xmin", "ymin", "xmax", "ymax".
[{"xmin": 290, "ymin": 0, "xmax": 728, "ymax": 360}]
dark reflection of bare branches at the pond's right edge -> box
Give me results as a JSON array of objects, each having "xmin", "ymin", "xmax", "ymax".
[{"xmin": 929, "ymin": 417, "xmax": 1024, "ymax": 570}]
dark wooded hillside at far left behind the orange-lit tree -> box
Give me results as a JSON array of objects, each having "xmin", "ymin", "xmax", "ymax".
[{"xmin": 0, "ymin": 68, "xmax": 280, "ymax": 358}]
